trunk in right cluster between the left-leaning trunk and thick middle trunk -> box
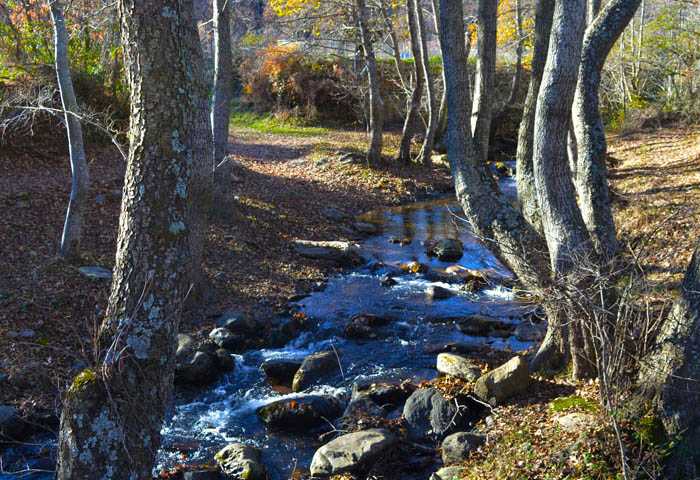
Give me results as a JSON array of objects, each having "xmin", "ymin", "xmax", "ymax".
[{"xmin": 515, "ymin": 0, "xmax": 554, "ymax": 231}]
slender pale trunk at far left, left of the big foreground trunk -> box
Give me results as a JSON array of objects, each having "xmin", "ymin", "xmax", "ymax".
[{"xmin": 49, "ymin": 0, "xmax": 90, "ymax": 258}]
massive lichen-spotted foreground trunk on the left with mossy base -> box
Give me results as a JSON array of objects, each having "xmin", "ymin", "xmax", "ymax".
[{"xmin": 57, "ymin": 0, "xmax": 200, "ymax": 480}]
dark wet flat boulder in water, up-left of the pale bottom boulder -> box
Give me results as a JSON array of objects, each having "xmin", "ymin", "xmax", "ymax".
[{"xmin": 257, "ymin": 395, "xmax": 343, "ymax": 431}]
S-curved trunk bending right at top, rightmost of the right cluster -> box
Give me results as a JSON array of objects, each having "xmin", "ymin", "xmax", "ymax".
[{"xmin": 572, "ymin": 0, "xmax": 641, "ymax": 260}]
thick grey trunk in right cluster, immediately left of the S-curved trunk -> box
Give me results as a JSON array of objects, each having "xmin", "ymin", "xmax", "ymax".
[{"xmin": 532, "ymin": 0, "xmax": 597, "ymax": 378}]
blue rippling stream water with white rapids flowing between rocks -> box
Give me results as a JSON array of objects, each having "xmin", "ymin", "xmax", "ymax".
[{"xmin": 0, "ymin": 174, "xmax": 531, "ymax": 480}]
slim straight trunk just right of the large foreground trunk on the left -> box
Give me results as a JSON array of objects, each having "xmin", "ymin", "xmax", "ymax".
[{"xmin": 211, "ymin": 0, "xmax": 233, "ymax": 208}]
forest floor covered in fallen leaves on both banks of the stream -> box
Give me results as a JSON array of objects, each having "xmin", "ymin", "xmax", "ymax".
[{"xmin": 0, "ymin": 123, "xmax": 700, "ymax": 478}]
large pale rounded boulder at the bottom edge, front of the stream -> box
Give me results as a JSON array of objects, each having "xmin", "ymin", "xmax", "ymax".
[{"xmin": 311, "ymin": 429, "xmax": 398, "ymax": 477}]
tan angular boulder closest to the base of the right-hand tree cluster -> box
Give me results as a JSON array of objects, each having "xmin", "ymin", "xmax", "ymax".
[{"xmin": 474, "ymin": 357, "xmax": 530, "ymax": 405}]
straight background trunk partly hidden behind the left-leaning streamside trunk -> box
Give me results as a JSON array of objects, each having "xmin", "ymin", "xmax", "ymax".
[{"xmin": 471, "ymin": 0, "xmax": 498, "ymax": 161}]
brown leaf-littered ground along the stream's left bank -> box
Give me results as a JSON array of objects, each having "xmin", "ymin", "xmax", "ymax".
[{"xmin": 0, "ymin": 126, "xmax": 450, "ymax": 410}]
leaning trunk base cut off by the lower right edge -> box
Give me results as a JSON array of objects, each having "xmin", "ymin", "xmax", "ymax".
[{"xmin": 639, "ymin": 244, "xmax": 700, "ymax": 480}]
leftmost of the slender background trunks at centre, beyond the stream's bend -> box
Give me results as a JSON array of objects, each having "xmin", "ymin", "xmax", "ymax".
[{"xmin": 355, "ymin": 0, "xmax": 384, "ymax": 163}]
